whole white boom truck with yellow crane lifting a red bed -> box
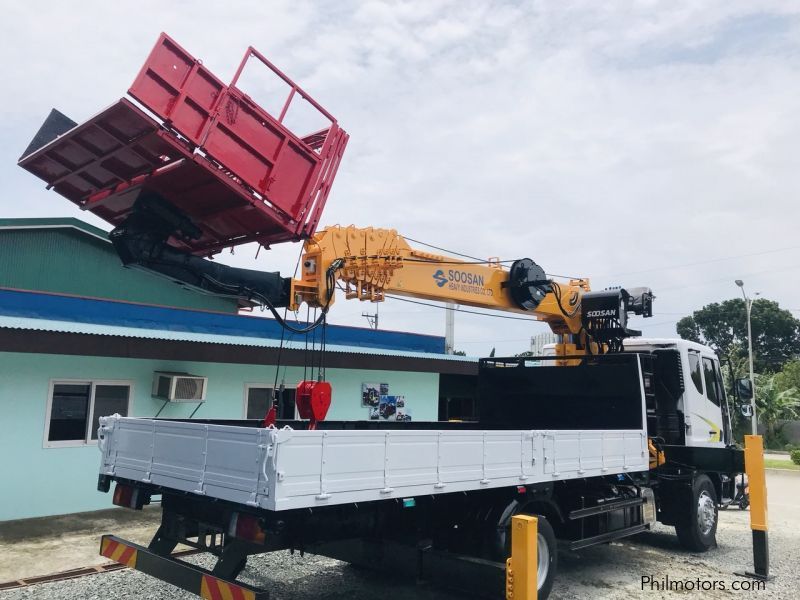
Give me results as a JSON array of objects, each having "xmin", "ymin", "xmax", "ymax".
[{"xmin": 20, "ymin": 34, "xmax": 756, "ymax": 599}]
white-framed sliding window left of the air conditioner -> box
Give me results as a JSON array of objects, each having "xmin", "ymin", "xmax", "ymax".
[{"xmin": 45, "ymin": 381, "xmax": 133, "ymax": 446}]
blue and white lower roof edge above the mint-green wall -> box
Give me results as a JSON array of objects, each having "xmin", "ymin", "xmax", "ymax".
[{"xmin": 0, "ymin": 289, "xmax": 478, "ymax": 375}]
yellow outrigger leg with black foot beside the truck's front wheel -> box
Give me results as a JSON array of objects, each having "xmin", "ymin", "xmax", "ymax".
[{"xmin": 744, "ymin": 435, "xmax": 769, "ymax": 579}]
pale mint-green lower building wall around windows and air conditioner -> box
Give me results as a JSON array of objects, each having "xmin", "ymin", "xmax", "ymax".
[{"xmin": 0, "ymin": 352, "xmax": 439, "ymax": 521}]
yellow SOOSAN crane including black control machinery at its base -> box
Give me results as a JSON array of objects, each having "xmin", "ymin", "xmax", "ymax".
[{"xmin": 289, "ymin": 225, "xmax": 653, "ymax": 356}]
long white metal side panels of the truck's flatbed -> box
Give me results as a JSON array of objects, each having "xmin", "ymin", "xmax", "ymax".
[{"xmin": 99, "ymin": 415, "xmax": 649, "ymax": 511}]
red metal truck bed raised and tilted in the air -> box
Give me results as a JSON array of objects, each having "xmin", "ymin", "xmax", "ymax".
[{"xmin": 20, "ymin": 34, "xmax": 348, "ymax": 254}]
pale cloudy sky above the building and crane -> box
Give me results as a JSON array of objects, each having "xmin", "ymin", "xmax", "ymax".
[{"xmin": 0, "ymin": 0, "xmax": 800, "ymax": 354}]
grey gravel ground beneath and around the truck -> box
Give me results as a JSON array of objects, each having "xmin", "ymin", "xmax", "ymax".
[{"xmin": 0, "ymin": 472, "xmax": 800, "ymax": 600}]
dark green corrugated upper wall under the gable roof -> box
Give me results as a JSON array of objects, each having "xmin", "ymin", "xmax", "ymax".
[{"xmin": 0, "ymin": 229, "xmax": 238, "ymax": 313}]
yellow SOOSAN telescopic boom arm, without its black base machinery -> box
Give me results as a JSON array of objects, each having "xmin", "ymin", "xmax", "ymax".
[{"xmin": 292, "ymin": 226, "xmax": 589, "ymax": 335}]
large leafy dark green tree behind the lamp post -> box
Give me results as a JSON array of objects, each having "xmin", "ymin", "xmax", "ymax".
[{"xmin": 677, "ymin": 298, "xmax": 800, "ymax": 373}]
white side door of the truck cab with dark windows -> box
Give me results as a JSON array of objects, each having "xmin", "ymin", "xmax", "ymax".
[{"xmin": 683, "ymin": 350, "xmax": 730, "ymax": 448}]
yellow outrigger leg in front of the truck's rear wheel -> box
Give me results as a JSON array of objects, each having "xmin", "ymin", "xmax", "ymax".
[{"xmin": 506, "ymin": 515, "xmax": 539, "ymax": 600}]
